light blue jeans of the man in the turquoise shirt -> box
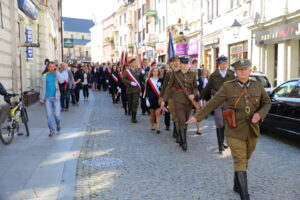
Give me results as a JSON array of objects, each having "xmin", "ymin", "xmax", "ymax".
[{"xmin": 45, "ymin": 97, "xmax": 61, "ymax": 131}]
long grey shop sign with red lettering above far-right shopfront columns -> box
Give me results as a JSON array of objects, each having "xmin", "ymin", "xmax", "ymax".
[{"xmin": 255, "ymin": 22, "xmax": 300, "ymax": 45}]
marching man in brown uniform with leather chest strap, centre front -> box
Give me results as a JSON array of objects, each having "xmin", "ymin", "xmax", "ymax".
[{"xmin": 162, "ymin": 58, "xmax": 198, "ymax": 151}]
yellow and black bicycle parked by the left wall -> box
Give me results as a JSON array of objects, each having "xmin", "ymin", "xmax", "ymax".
[{"xmin": 0, "ymin": 90, "xmax": 32, "ymax": 145}]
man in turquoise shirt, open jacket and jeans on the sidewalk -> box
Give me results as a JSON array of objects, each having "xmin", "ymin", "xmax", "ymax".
[{"xmin": 39, "ymin": 61, "xmax": 61, "ymax": 137}]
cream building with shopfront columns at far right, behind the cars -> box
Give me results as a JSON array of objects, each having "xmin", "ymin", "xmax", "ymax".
[{"xmin": 249, "ymin": 0, "xmax": 300, "ymax": 86}]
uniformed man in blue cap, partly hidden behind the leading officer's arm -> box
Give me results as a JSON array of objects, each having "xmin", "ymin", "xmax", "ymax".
[{"xmin": 201, "ymin": 55, "xmax": 235, "ymax": 153}]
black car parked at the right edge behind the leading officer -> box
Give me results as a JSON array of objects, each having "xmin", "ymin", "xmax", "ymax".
[{"xmin": 261, "ymin": 78, "xmax": 300, "ymax": 138}]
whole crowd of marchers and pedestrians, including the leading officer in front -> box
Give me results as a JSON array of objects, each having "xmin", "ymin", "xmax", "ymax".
[{"xmin": 40, "ymin": 56, "xmax": 271, "ymax": 200}]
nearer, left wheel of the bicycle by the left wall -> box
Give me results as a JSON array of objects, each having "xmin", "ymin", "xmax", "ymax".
[{"xmin": 0, "ymin": 112, "xmax": 14, "ymax": 145}]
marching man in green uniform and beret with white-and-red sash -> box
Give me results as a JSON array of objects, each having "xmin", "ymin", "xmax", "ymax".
[{"xmin": 122, "ymin": 59, "xmax": 143, "ymax": 123}]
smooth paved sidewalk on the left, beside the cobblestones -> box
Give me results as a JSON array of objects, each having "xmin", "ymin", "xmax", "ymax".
[{"xmin": 0, "ymin": 92, "xmax": 94, "ymax": 200}]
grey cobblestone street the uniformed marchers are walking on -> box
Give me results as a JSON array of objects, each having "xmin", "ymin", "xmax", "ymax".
[{"xmin": 75, "ymin": 92, "xmax": 300, "ymax": 200}]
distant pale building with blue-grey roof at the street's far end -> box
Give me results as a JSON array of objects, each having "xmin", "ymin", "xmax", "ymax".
[{"xmin": 62, "ymin": 17, "xmax": 94, "ymax": 62}]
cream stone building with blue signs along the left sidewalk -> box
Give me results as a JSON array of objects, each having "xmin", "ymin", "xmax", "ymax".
[{"xmin": 0, "ymin": 0, "xmax": 62, "ymax": 106}]
